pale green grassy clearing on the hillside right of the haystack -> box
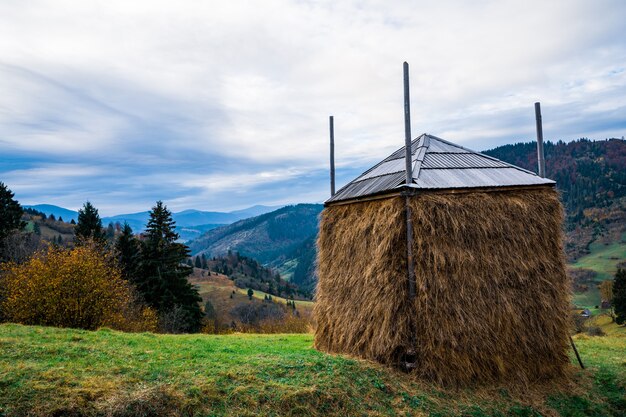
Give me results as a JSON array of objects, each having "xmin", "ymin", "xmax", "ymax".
[{"xmin": 570, "ymin": 235, "xmax": 626, "ymax": 308}]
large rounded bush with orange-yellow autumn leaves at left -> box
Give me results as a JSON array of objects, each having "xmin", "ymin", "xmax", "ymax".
[{"xmin": 0, "ymin": 242, "xmax": 157, "ymax": 332}]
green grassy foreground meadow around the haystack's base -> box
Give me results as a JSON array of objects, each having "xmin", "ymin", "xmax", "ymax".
[{"xmin": 0, "ymin": 324, "xmax": 626, "ymax": 416}]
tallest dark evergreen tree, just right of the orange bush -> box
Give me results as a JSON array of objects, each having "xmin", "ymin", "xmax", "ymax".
[{"xmin": 137, "ymin": 201, "xmax": 202, "ymax": 332}]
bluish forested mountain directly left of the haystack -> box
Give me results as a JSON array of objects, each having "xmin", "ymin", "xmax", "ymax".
[{"xmin": 188, "ymin": 204, "xmax": 323, "ymax": 278}]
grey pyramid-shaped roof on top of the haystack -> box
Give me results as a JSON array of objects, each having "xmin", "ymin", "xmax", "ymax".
[{"xmin": 326, "ymin": 134, "xmax": 555, "ymax": 203}]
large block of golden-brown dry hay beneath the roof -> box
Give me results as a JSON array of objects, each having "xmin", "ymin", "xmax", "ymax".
[{"xmin": 315, "ymin": 187, "xmax": 570, "ymax": 385}]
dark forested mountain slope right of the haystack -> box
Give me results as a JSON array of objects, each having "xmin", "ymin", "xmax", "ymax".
[{"xmin": 484, "ymin": 139, "xmax": 626, "ymax": 261}]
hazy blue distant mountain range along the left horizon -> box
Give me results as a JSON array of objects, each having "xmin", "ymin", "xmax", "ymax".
[{"xmin": 24, "ymin": 204, "xmax": 281, "ymax": 240}]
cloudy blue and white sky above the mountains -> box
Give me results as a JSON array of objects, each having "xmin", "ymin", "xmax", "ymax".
[{"xmin": 0, "ymin": 0, "xmax": 626, "ymax": 215}]
